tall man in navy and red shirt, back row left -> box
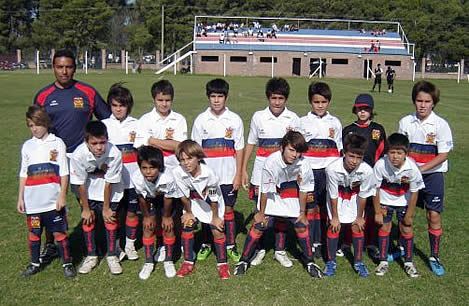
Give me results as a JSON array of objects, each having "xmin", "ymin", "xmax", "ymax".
[{"xmin": 33, "ymin": 50, "xmax": 111, "ymax": 263}]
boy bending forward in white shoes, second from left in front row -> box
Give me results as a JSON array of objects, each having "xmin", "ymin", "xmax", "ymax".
[{"xmin": 70, "ymin": 121, "xmax": 124, "ymax": 274}]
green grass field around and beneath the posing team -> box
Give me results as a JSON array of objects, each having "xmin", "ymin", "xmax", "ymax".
[{"xmin": 0, "ymin": 71, "xmax": 469, "ymax": 305}]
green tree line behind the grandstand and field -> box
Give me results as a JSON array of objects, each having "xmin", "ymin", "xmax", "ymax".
[{"xmin": 0, "ymin": 0, "xmax": 469, "ymax": 62}]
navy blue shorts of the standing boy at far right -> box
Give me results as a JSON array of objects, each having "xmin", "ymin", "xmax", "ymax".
[{"xmin": 417, "ymin": 172, "xmax": 445, "ymax": 213}]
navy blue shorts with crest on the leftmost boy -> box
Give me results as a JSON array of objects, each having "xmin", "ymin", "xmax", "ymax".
[{"xmin": 26, "ymin": 207, "xmax": 68, "ymax": 236}]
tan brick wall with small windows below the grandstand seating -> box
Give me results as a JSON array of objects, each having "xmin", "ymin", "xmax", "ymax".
[{"xmin": 193, "ymin": 50, "xmax": 413, "ymax": 80}]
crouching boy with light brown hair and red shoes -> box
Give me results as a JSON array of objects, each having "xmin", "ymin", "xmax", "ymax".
[{"xmin": 173, "ymin": 139, "xmax": 230, "ymax": 279}]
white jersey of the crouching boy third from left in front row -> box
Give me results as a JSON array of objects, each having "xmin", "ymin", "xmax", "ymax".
[{"xmin": 132, "ymin": 167, "xmax": 181, "ymax": 199}]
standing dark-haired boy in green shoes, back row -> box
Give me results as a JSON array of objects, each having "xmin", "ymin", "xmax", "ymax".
[{"xmin": 191, "ymin": 79, "xmax": 244, "ymax": 262}]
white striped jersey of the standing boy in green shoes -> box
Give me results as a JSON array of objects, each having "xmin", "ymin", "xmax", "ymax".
[{"xmin": 191, "ymin": 108, "xmax": 244, "ymax": 185}]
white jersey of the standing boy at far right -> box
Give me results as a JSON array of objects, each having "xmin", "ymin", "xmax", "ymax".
[{"xmin": 399, "ymin": 111, "xmax": 453, "ymax": 174}]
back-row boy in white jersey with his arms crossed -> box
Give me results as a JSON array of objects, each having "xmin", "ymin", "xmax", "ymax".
[{"xmin": 134, "ymin": 80, "xmax": 187, "ymax": 262}]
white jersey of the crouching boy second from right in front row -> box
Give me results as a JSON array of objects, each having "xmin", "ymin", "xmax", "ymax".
[{"xmin": 326, "ymin": 157, "xmax": 376, "ymax": 223}]
